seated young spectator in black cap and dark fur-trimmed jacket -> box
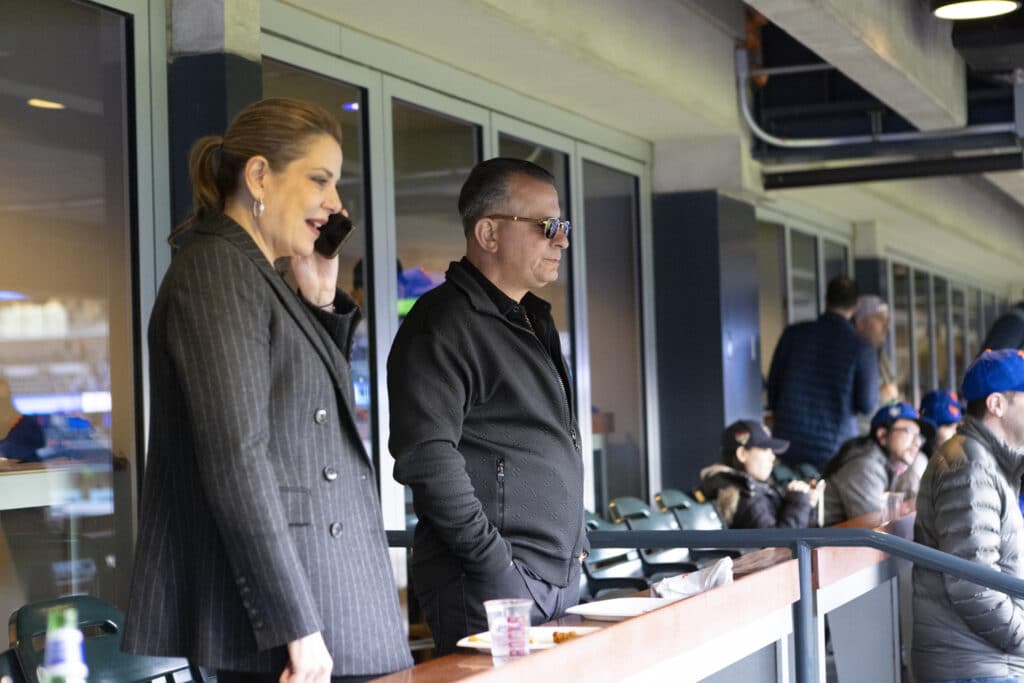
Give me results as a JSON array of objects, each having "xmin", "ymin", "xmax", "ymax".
[{"xmin": 699, "ymin": 420, "xmax": 823, "ymax": 528}]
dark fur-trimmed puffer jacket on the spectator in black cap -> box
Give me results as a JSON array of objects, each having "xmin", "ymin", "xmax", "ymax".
[{"xmin": 700, "ymin": 465, "xmax": 814, "ymax": 528}]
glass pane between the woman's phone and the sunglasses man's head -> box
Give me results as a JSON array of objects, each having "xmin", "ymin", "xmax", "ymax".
[{"xmin": 391, "ymin": 99, "xmax": 480, "ymax": 309}]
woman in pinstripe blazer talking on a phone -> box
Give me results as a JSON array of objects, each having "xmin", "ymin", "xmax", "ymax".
[{"xmin": 124, "ymin": 98, "xmax": 412, "ymax": 683}]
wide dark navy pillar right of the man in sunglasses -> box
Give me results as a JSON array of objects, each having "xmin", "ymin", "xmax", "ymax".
[{"xmin": 653, "ymin": 191, "xmax": 764, "ymax": 490}]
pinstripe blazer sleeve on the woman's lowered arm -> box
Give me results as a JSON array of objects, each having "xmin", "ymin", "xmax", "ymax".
[{"xmin": 167, "ymin": 248, "xmax": 323, "ymax": 649}]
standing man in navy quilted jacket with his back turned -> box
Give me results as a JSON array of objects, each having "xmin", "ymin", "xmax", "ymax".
[{"xmin": 768, "ymin": 278, "xmax": 879, "ymax": 478}]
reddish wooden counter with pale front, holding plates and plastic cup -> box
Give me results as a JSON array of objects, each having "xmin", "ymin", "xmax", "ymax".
[{"xmin": 377, "ymin": 549, "xmax": 800, "ymax": 683}]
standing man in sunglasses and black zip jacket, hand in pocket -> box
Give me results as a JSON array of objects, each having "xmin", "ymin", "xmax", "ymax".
[{"xmin": 388, "ymin": 159, "xmax": 587, "ymax": 654}]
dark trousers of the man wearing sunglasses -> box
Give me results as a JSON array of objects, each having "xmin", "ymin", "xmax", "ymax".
[{"xmin": 417, "ymin": 560, "xmax": 580, "ymax": 656}]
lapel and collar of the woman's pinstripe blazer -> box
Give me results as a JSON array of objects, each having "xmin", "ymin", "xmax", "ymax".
[{"xmin": 195, "ymin": 214, "xmax": 369, "ymax": 450}]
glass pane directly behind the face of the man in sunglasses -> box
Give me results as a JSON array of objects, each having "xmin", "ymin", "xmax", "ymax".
[{"xmin": 498, "ymin": 133, "xmax": 574, "ymax": 362}]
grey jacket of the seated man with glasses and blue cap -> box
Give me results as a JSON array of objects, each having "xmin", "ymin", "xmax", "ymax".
[{"xmin": 822, "ymin": 436, "xmax": 896, "ymax": 526}]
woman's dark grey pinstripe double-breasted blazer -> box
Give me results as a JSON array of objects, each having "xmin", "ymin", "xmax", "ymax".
[{"xmin": 123, "ymin": 216, "xmax": 412, "ymax": 676}]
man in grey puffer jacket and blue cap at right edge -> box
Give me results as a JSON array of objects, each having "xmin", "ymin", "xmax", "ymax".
[{"xmin": 913, "ymin": 349, "xmax": 1024, "ymax": 683}]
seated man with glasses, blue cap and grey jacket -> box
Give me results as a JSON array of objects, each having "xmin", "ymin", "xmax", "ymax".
[{"xmin": 822, "ymin": 403, "xmax": 931, "ymax": 526}]
